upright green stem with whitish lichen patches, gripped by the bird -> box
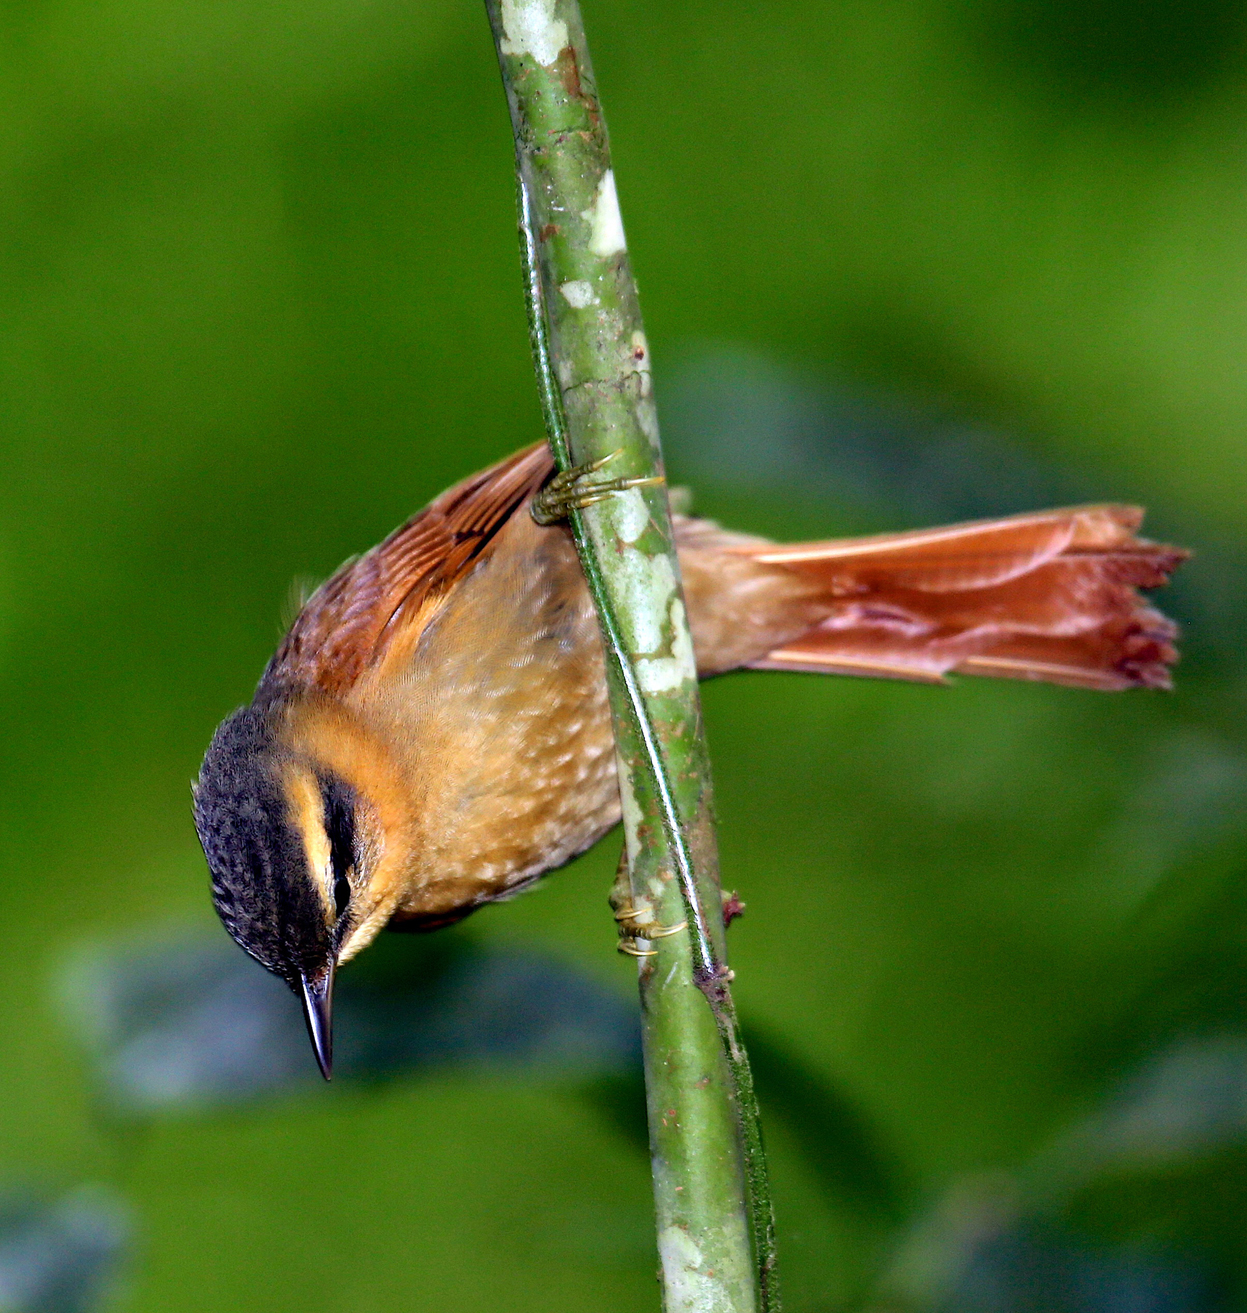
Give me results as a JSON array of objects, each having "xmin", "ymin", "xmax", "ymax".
[{"xmin": 486, "ymin": 0, "xmax": 778, "ymax": 1313}]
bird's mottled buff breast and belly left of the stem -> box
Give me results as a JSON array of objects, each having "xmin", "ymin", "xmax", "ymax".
[{"xmin": 375, "ymin": 516, "xmax": 620, "ymax": 920}]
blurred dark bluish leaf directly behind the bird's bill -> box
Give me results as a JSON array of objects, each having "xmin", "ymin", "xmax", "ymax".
[{"xmin": 62, "ymin": 934, "xmax": 639, "ymax": 1113}]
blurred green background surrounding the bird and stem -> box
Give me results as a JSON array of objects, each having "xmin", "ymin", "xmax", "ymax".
[{"xmin": 0, "ymin": 0, "xmax": 1247, "ymax": 1313}]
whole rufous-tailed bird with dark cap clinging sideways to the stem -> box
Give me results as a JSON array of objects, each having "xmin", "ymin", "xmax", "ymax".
[{"xmin": 193, "ymin": 444, "xmax": 1185, "ymax": 1079}]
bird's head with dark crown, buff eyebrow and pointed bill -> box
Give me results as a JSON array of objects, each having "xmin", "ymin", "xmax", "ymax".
[{"xmin": 194, "ymin": 699, "xmax": 404, "ymax": 1079}]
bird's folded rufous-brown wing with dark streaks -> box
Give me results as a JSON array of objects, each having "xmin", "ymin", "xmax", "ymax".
[{"xmin": 265, "ymin": 442, "xmax": 554, "ymax": 695}]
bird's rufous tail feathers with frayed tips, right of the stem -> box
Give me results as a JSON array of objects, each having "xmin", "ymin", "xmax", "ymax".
[{"xmin": 729, "ymin": 506, "xmax": 1187, "ymax": 689}]
